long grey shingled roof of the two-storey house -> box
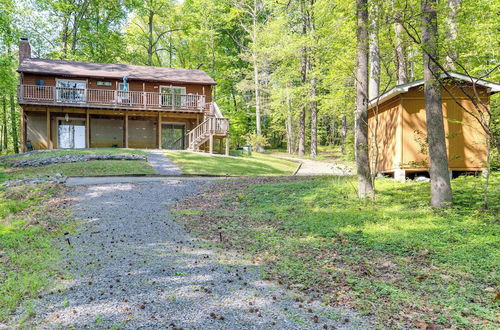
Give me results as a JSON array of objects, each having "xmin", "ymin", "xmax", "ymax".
[{"xmin": 17, "ymin": 58, "xmax": 215, "ymax": 85}]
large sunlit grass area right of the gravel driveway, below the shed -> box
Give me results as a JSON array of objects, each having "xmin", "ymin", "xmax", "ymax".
[{"xmin": 177, "ymin": 173, "xmax": 500, "ymax": 329}]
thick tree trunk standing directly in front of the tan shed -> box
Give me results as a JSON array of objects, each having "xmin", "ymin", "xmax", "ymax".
[{"xmin": 420, "ymin": 0, "xmax": 452, "ymax": 207}]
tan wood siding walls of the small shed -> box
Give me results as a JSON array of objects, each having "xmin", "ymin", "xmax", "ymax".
[{"xmin": 368, "ymin": 86, "xmax": 489, "ymax": 172}]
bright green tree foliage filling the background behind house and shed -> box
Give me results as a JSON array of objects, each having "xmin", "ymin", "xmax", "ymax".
[{"xmin": 0, "ymin": 0, "xmax": 500, "ymax": 154}]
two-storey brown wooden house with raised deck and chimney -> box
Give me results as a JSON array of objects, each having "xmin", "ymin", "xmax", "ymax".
[{"xmin": 17, "ymin": 39, "xmax": 229, "ymax": 152}]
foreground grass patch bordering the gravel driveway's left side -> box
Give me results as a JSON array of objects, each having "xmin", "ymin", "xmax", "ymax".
[{"xmin": 0, "ymin": 185, "xmax": 72, "ymax": 322}]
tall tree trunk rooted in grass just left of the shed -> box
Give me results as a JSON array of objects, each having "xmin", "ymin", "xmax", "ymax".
[{"xmin": 356, "ymin": 0, "xmax": 374, "ymax": 198}]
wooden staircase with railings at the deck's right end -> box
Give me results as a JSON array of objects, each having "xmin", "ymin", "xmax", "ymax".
[{"xmin": 186, "ymin": 103, "xmax": 229, "ymax": 155}]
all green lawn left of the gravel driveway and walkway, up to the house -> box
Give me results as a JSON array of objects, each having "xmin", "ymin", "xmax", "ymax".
[{"xmin": 0, "ymin": 148, "xmax": 154, "ymax": 322}]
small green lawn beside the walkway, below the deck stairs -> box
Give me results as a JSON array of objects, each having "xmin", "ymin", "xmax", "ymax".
[{"xmin": 166, "ymin": 152, "xmax": 298, "ymax": 176}]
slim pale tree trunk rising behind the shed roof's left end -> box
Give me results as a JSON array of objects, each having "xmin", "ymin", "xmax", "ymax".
[{"xmin": 368, "ymin": 0, "xmax": 380, "ymax": 100}]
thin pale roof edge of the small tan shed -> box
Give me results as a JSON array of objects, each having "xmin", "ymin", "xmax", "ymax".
[{"xmin": 368, "ymin": 72, "xmax": 500, "ymax": 109}]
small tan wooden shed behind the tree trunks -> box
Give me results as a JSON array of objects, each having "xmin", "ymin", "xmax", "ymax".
[{"xmin": 368, "ymin": 73, "xmax": 500, "ymax": 180}]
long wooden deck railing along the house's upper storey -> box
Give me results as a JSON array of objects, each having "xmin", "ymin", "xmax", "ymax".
[{"xmin": 18, "ymin": 85, "xmax": 205, "ymax": 112}]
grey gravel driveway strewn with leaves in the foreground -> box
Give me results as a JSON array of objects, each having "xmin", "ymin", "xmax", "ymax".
[{"xmin": 24, "ymin": 179, "xmax": 369, "ymax": 329}]
